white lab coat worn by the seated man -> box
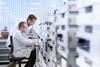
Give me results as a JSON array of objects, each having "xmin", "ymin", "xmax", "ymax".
[{"xmin": 13, "ymin": 30, "xmax": 35, "ymax": 57}]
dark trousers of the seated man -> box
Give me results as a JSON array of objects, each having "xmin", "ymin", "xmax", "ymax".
[{"xmin": 25, "ymin": 49, "xmax": 36, "ymax": 67}]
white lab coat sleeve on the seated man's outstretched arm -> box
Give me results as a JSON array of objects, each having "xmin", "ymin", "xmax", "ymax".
[{"xmin": 13, "ymin": 32, "xmax": 35, "ymax": 46}]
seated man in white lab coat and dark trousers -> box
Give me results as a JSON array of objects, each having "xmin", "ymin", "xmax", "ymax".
[{"xmin": 13, "ymin": 22, "xmax": 36, "ymax": 67}]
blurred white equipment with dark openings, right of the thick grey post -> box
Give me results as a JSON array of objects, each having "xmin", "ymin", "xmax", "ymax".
[{"xmin": 77, "ymin": 1, "xmax": 100, "ymax": 67}]
